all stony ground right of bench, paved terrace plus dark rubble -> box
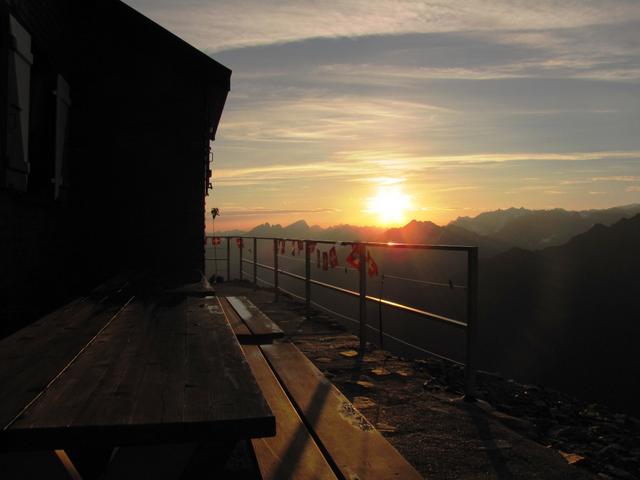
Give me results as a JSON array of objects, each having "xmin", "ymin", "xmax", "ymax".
[{"xmin": 218, "ymin": 283, "xmax": 640, "ymax": 479}]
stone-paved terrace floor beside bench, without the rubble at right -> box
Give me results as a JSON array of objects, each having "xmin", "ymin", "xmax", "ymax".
[{"xmin": 215, "ymin": 282, "xmax": 606, "ymax": 479}]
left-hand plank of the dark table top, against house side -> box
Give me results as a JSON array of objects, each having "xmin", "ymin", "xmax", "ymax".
[{"xmin": 0, "ymin": 287, "xmax": 131, "ymax": 428}]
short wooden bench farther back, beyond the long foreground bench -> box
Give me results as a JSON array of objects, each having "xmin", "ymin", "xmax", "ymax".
[{"xmin": 221, "ymin": 296, "xmax": 284, "ymax": 344}]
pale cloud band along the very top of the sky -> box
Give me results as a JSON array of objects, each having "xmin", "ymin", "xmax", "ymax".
[{"xmin": 127, "ymin": 0, "xmax": 640, "ymax": 52}]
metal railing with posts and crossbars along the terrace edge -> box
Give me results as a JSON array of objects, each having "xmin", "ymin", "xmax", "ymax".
[{"xmin": 205, "ymin": 236, "xmax": 478, "ymax": 400}]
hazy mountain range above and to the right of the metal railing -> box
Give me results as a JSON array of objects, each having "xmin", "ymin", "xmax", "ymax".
[{"xmin": 220, "ymin": 205, "xmax": 640, "ymax": 414}]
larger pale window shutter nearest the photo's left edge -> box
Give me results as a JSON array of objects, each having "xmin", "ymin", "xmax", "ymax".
[{"xmin": 6, "ymin": 16, "xmax": 33, "ymax": 191}]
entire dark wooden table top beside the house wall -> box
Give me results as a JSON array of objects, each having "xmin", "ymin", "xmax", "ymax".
[{"xmin": 0, "ymin": 282, "xmax": 275, "ymax": 449}]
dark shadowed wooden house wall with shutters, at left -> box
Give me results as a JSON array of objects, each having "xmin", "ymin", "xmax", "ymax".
[{"xmin": 0, "ymin": 0, "xmax": 231, "ymax": 335}]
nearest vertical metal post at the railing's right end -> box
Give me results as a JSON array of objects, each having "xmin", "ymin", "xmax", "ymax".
[{"xmin": 464, "ymin": 247, "xmax": 478, "ymax": 402}]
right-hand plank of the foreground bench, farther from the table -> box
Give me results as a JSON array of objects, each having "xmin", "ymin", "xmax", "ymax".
[{"xmin": 261, "ymin": 343, "xmax": 422, "ymax": 479}]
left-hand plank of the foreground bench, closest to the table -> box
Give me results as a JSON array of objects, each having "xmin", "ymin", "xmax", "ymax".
[{"xmin": 242, "ymin": 345, "xmax": 336, "ymax": 480}]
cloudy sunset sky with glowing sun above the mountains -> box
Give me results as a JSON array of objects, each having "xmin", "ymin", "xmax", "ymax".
[{"xmin": 126, "ymin": 0, "xmax": 640, "ymax": 230}]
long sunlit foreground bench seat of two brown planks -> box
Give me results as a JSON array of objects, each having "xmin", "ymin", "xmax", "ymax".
[{"xmin": 229, "ymin": 302, "xmax": 422, "ymax": 480}]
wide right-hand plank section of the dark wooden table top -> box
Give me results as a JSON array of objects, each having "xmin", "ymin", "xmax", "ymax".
[{"xmin": 2, "ymin": 295, "xmax": 275, "ymax": 448}]
